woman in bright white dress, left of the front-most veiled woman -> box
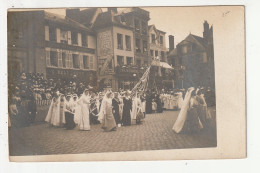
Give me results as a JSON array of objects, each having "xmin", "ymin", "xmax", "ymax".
[{"xmin": 74, "ymin": 89, "xmax": 90, "ymax": 131}]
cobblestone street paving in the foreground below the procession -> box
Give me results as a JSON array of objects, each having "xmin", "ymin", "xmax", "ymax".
[{"xmin": 9, "ymin": 108, "xmax": 217, "ymax": 156}]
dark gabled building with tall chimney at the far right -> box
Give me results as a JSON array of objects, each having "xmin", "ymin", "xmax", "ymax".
[{"xmin": 168, "ymin": 21, "xmax": 215, "ymax": 88}]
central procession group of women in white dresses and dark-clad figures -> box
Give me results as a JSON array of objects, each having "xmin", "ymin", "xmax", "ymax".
[{"xmin": 45, "ymin": 86, "xmax": 145, "ymax": 131}]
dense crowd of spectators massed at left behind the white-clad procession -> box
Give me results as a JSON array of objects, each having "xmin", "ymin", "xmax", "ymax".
[{"xmin": 8, "ymin": 73, "xmax": 91, "ymax": 127}]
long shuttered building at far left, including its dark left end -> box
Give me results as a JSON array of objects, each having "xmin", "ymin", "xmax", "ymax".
[{"xmin": 8, "ymin": 10, "xmax": 97, "ymax": 85}]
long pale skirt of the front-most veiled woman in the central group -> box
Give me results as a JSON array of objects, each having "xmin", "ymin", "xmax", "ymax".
[{"xmin": 101, "ymin": 108, "xmax": 116, "ymax": 132}]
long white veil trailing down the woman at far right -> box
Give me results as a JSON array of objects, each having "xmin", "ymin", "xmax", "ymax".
[{"xmin": 172, "ymin": 88, "xmax": 194, "ymax": 133}]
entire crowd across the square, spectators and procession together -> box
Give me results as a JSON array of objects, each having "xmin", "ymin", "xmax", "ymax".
[{"xmin": 9, "ymin": 73, "xmax": 215, "ymax": 133}]
